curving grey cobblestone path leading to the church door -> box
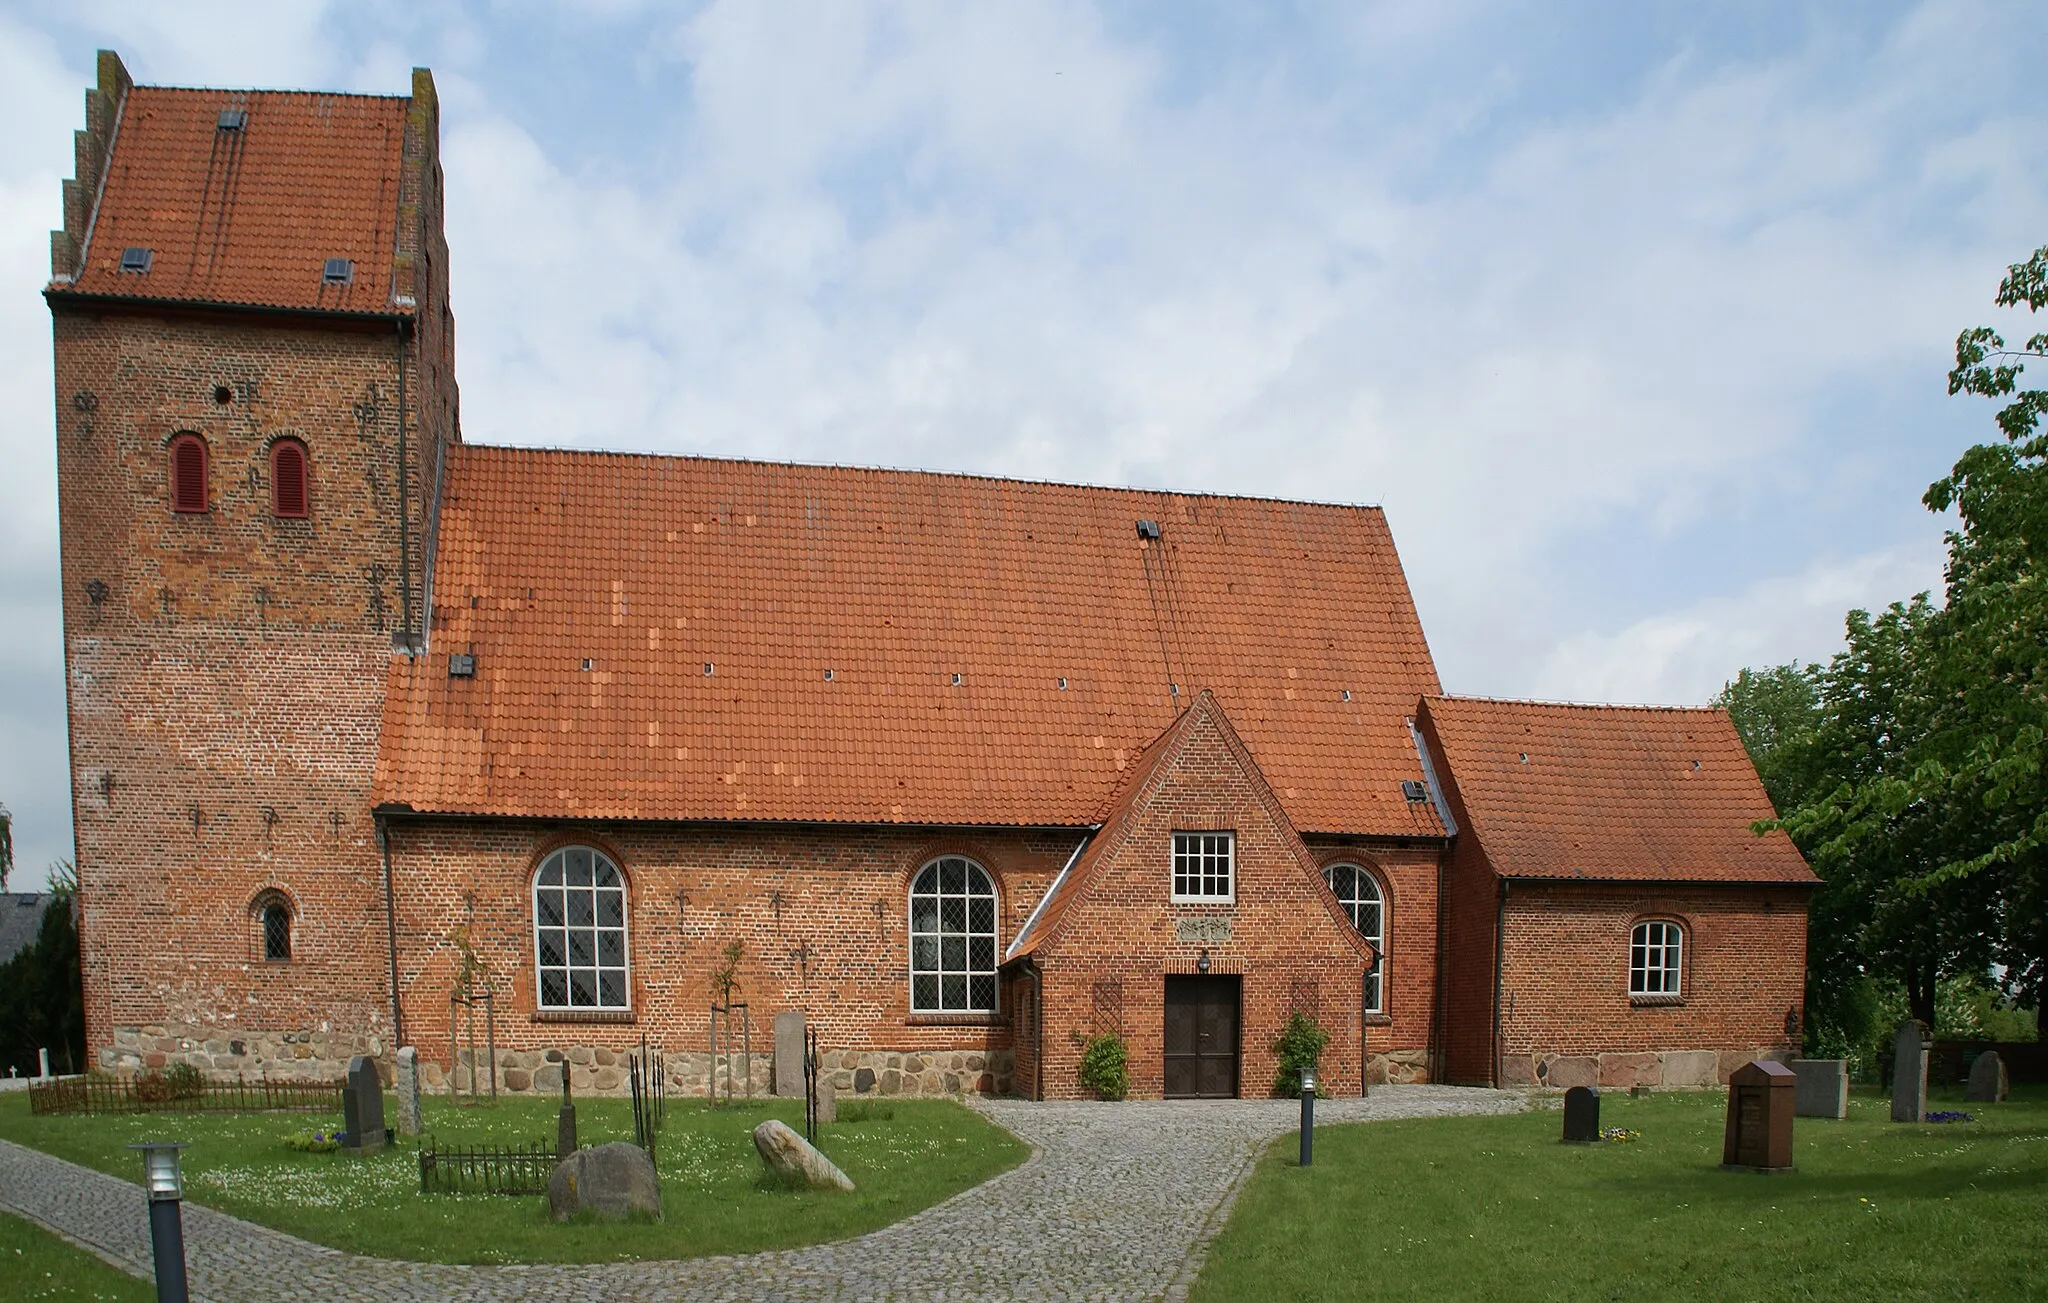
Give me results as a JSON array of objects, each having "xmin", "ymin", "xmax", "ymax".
[{"xmin": 0, "ymin": 1086, "xmax": 1526, "ymax": 1303}]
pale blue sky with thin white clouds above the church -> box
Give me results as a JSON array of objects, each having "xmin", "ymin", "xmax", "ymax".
[{"xmin": 0, "ymin": 0, "xmax": 2048, "ymax": 887}]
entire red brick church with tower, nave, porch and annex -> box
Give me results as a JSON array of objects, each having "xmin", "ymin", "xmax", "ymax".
[{"xmin": 45, "ymin": 53, "xmax": 1815, "ymax": 1098}]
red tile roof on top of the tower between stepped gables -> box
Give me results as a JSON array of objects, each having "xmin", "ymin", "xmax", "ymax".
[{"xmin": 51, "ymin": 86, "xmax": 412, "ymax": 313}]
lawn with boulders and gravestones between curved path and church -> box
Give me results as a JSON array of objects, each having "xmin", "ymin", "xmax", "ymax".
[{"xmin": 0, "ymin": 1094, "xmax": 1030, "ymax": 1262}]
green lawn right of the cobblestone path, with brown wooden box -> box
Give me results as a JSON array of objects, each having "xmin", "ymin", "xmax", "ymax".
[{"xmin": 1194, "ymin": 1086, "xmax": 2048, "ymax": 1301}]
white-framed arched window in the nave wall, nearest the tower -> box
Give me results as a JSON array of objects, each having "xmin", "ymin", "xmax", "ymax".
[{"xmin": 532, "ymin": 846, "xmax": 631, "ymax": 1010}]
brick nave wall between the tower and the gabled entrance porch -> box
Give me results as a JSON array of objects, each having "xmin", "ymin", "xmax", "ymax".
[{"xmin": 377, "ymin": 817, "xmax": 1079, "ymax": 1092}]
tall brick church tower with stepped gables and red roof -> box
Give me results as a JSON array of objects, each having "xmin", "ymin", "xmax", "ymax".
[{"xmin": 45, "ymin": 51, "xmax": 461, "ymax": 1076}]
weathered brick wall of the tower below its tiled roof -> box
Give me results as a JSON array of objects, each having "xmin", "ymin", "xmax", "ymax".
[{"xmin": 53, "ymin": 309, "xmax": 419, "ymax": 1061}]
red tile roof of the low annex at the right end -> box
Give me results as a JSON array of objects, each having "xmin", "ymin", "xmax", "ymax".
[{"xmin": 1421, "ymin": 697, "xmax": 1819, "ymax": 883}]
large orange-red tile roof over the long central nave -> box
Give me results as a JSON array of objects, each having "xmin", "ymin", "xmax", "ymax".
[{"xmin": 377, "ymin": 445, "xmax": 1442, "ymax": 836}]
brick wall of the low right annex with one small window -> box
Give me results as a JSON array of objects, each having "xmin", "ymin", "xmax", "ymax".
[{"xmin": 1501, "ymin": 881, "xmax": 1806, "ymax": 1086}]
